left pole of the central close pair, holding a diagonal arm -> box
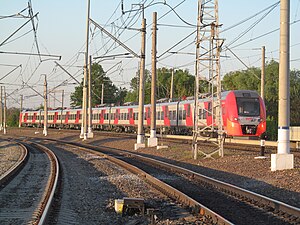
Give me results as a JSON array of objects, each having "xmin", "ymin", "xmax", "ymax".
[{"xmin": 135, "ymin": 18, "xmax": 146, "ymax": 150}]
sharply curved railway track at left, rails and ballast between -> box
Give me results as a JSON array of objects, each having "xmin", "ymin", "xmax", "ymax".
[{"xmin": 0, "ymin": 142, "xmax": 59, "ymax": 224}]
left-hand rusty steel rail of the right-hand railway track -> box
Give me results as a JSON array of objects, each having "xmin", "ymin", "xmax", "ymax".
[{"xmin": 44, "ymin": 139, "xmax": 233, "ymax": 225}]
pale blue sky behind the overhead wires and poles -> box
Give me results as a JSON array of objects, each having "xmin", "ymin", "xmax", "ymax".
[{"xmin": 0, "ymin": 0, "xmax": 300, "ymax": 108}]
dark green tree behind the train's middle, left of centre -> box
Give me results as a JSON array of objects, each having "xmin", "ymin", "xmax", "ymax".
[{"xmin": 71, "ymin": 63, "xmax": 127, "ymax": 107}]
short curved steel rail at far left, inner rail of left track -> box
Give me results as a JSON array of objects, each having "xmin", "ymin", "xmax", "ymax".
[{"xmin": 0, "ymin": 143, "xmax": 28, "ymax": 186}]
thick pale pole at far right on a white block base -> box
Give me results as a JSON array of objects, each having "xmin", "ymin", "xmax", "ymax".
[{"xmin": 271, "ymin": 0, "xmax": 294, "ymax": 171}]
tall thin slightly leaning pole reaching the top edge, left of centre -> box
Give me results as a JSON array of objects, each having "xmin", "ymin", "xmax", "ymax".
[{"xmin": 80, "ymin": 0, "xmax": 90, "ymax": 140}]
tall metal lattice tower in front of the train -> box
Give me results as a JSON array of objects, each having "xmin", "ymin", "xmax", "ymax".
[{"xmin": 192, "ymin": 0, "xmax": 224, "ymax": 159}]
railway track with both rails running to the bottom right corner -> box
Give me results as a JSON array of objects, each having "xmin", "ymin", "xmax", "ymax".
[{"xmin": 37, "ymin": 140, "xmax": 300, "ymax": 224}]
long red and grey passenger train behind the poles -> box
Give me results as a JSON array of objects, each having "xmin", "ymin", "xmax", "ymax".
[{"xmin": 20, "ymin": 90, "xmax": 266, "ymax": 137}]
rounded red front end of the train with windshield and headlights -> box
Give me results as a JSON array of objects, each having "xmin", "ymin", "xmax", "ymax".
[{"xmin": 223, "ymin": 90, "xmax": 266, "ymax": 137}]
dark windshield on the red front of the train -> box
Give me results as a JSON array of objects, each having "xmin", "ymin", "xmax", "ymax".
[{"xmin": 236, "ymin": 98, "xmax": 260, "ymax": 116}]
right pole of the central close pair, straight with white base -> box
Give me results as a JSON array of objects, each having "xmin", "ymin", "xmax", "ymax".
[{"xmin": 148, "ymin": 12, "xmax": 157, "ymax": 147}]
